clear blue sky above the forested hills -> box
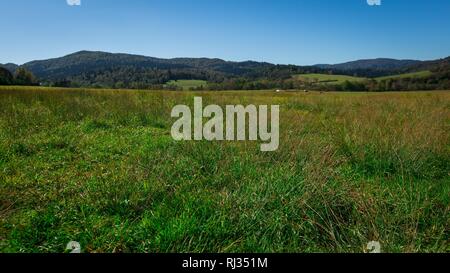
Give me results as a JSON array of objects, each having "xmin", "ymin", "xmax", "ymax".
[{"xmin": 0, "ymin": 0, "xmax": 450, "ymax": 65}]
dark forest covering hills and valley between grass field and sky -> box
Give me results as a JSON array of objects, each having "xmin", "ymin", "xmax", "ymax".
[{"xmin": 0, "ymin": 51, "xmax": 450, "ymax": 91}]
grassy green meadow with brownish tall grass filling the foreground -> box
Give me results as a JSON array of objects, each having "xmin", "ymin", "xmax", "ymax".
[{"xmin": 0, "ymin": 87, "xmax": 450, "ymax": 253}]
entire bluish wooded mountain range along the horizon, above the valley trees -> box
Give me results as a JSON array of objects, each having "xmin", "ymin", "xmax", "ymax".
[{"xmin": 0, "ymin": 51, "xmax": 450, "ymax": 88}]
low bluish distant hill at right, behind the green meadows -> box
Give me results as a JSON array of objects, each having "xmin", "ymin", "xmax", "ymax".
[{"xmin": 316, "ymin": 58, "xmax": 423, "ymax": 71}]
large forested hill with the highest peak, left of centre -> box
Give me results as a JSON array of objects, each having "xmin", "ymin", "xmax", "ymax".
[{"xmin": 18, "ymin": 51, "xmax": 322, "ymax": 86}]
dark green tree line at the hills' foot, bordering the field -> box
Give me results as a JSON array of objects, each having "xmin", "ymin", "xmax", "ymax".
[{"xmin": 0, "ymin": 63, "xmax": 450, "ymax": 91}]
